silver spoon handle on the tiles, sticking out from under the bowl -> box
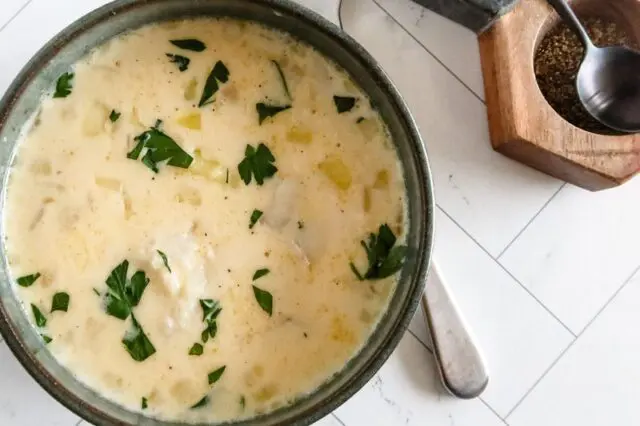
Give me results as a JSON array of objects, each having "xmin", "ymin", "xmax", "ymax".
[{"xmin": 422, "ymin": 262, "xmax": 489, "ymax": 399}]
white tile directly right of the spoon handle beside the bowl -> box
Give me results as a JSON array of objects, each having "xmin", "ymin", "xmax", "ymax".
[{"xmin": 412, "ymin": 210, "xmax": 573, "ymax": 416}]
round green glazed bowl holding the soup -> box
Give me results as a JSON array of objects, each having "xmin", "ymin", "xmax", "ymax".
[{"xmin": 0, "ymin": 0, "xmax": 434, "ymax": 426}]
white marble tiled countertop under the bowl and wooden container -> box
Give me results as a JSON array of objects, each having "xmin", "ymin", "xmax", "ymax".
[{"xmin": 0, "ymin": 0, "xmax": 640, "ymax": 426}]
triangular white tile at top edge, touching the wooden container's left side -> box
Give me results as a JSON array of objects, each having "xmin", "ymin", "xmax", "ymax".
[{"xmin": 372, "ymin": 0, "xmax": 484, "ymax": 99}]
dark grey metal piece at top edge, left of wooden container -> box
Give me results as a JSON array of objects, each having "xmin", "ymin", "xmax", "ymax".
[{"xmin": 413, "ymin": 0, "xmax": 518, "ymax": 33}]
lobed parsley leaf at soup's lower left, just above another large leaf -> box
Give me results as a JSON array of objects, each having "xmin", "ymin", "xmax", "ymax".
[{"xmin": 104, "ymin": 260, "xmax": 149, "ymax": 320}]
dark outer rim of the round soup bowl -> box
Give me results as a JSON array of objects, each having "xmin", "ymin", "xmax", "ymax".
[{"xmin": 0, "ymin": 0, "xmax": 435, "ymax": 425}]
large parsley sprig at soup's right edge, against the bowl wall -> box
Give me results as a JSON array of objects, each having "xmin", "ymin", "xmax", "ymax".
[{"xmin": 349, "ymin": 223, "xmax": 407, "ymax": 281}]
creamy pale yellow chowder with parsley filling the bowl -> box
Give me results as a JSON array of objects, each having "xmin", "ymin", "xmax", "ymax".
[{"xmin": 4, "ymin": 19, "xmax": 406, "ymax": 422}]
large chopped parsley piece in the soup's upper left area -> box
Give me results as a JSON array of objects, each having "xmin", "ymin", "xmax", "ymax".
[{"xmin": 127, "ymin": 126, "xmax": 193, "ymax": 173}]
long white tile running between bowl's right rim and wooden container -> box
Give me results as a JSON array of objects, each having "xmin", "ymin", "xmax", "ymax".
[{"xmin": 342, "ymin": 0, "xmax": 561, "ymax": 255}]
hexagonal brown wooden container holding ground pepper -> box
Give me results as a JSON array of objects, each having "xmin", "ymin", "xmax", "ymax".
[{"xmin": 479, "ymin": 0, "xmax": 640, "ymax": 191}]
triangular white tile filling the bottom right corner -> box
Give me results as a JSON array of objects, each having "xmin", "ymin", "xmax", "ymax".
[{"xmin": 509, "ymin": 273, "xmax": 640, "ymax": 426}]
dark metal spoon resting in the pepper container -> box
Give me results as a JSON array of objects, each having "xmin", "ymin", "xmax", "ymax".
[{"xmin": 548, "ymin": 0, "xmax": 640, "ymax": 133}]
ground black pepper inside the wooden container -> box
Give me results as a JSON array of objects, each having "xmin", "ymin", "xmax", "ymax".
[{"xmin": 534, "ymin": 18, "xmax": 637, "ymax": 134}]
